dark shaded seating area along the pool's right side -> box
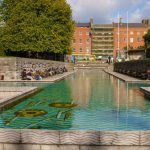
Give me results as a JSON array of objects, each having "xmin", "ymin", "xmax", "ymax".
[{"xmin": 114, "ymin": 60, "xmax": 150, "ymax": 80}]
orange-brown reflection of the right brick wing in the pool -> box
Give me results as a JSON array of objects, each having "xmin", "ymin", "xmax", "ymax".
[{"xmin": 113, "ymin": 77, "xmax": 145, "ymax": 109}]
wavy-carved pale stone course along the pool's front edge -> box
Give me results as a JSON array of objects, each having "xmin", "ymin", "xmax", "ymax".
[{"xmin": 0, "ymin": 129, "xmax": 150, "ymax": 146}]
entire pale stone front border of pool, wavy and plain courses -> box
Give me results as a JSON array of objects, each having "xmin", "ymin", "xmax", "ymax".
[{"xmin": 0, "ymin": 129, "xmax": 150, "ymax": 150}]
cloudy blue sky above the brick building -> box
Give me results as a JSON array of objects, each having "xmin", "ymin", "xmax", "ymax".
[{"xmin": 67, "ymin": 0, "xmax": 150, "ymax": 23}]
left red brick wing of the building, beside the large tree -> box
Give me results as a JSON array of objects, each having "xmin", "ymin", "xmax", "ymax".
[{"xmin": 72, "ymin": 23, "xmax": 91, "ymax": 59}]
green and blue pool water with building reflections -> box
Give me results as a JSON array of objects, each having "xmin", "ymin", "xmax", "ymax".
[{"xmin": 0, "ymin": 70, "xmax": 150, "ymax": 130}]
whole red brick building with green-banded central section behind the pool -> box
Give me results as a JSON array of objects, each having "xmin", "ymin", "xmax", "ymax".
[{"xmin": 72, "ymin": 19, "xmax": 149, "ymax": 59}]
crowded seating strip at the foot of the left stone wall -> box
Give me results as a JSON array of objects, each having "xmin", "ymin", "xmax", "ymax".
[{"xmin": 21, "ymin": 66, "xmax": 68, "ymax": 80}]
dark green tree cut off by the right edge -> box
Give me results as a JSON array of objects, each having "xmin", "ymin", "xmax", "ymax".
[{"xmin": 144, "ymin": 29, "xmax": 150, "ymax": 58}]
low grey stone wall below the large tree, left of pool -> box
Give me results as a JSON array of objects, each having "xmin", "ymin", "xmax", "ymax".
[{"xmin": 0, "ymin": 57, "xmax": 73, "ymax": 80}]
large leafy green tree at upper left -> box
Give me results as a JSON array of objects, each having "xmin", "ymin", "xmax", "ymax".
[{"xmin": 0, "ymin": 0, "xmax": 74, "ymax": 54}]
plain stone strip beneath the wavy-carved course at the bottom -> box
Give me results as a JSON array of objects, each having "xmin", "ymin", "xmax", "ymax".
[{"xmin": 0, "ymin": 144, "xmax": 150, "ymax": 150}]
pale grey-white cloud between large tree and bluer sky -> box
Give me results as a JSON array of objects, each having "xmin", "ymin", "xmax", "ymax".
[{"xmin": 68, "ymin": 0, "xmax": 115, "ymax": 22}]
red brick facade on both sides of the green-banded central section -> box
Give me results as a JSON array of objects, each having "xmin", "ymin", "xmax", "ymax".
[{"xmin": 72, "ymin": 23, "xmax": 148, "ymax": 58}]
